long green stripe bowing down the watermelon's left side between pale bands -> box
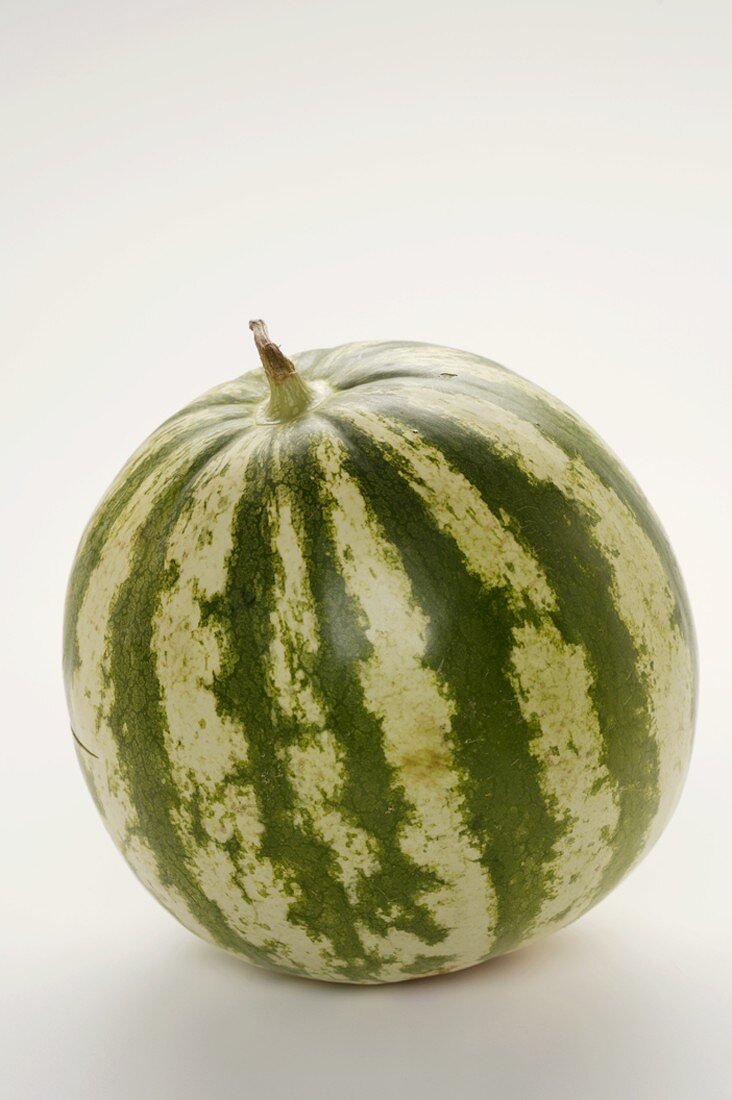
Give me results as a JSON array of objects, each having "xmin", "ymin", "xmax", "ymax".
[{"xmin": 101, "ymin": 429, "xmax": 299, "ymax": 969}]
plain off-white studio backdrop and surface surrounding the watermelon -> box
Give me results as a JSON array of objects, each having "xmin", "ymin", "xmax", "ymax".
[{"xmin": 0, "ymin": 0, "xmax": 732, "ymax": 1100}]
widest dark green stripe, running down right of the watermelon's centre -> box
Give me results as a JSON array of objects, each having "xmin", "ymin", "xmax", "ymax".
[{"xmin": 328, "ymin": 413, "xmax": 565, "ymax": 954}]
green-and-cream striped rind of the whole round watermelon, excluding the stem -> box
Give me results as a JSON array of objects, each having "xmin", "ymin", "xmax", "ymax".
[{"xmin": 64, "ymin": 343, "xmax": 696, "ymax": 982}]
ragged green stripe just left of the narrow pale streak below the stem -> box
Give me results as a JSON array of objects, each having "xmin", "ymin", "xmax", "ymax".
[{"xmin": 201, "ymin": 426, "xmax": 375, "ymax": 980}]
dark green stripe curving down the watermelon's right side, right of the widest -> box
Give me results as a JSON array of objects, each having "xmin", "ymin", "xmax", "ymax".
[{"xmin": 339, "ymin": 399, "xmax": 659, "ymax": 902}]
